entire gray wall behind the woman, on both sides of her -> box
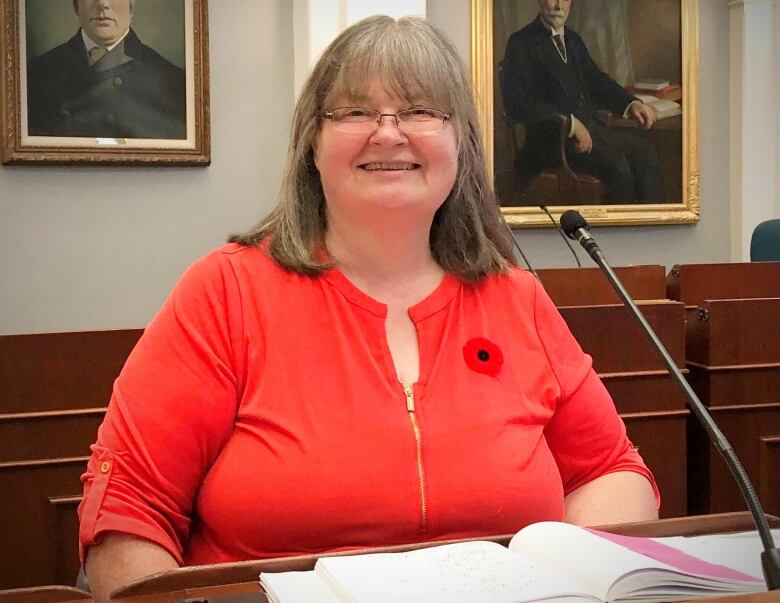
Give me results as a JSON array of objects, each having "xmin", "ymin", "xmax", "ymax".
[{"xmin": 0, "ymin": 0, "xmax": 729, "ymax": 334}]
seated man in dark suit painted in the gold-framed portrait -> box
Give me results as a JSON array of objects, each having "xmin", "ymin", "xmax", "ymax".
[{"xmin": 501, "ymin": 0, "xmax": 663, "ymax": 204}]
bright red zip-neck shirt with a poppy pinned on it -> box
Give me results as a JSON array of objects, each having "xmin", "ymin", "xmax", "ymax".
[{"xmin": 79, "ymin": 245, "xmax": 653, "ymax": 564}]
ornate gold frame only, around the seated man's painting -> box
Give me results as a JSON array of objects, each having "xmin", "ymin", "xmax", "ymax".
[{"xmin": 471, "ymin": 0, "xmax": 700, "ymax": 227}]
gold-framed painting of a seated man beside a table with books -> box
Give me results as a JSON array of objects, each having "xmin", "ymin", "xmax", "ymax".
[{"xmin": 471, "ymin": 0, "xmax": 700, "ymax": 226}]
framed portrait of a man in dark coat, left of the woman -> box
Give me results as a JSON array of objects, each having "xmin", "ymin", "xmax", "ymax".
[{"xmin": 0, "ymin": 0, "xmax": 211, "ymax": 166}]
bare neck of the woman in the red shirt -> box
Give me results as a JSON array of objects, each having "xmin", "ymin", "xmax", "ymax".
[{"xmin": 325, "ymin": 212, "xmax": 444, "ymax": 302}]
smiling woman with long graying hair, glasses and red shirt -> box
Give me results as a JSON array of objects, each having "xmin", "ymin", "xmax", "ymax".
[{"xmin": 80, "ymin": 17, "xmax": 657, "ymax": 599}]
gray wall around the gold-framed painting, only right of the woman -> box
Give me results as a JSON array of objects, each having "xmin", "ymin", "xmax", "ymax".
[{"xmin": 428, "ymin": 0, "xmax": 730, "ymax": 268}]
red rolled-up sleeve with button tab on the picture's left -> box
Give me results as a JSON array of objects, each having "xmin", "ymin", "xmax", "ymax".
[{"xmin": 79, "ymin": 251, "xmax": 244, "ymax": 563}]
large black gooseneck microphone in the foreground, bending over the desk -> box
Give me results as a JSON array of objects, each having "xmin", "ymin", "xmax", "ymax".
[{"xmin": 561, "ymin": 210, "xmax": 780, "ymax": 590}]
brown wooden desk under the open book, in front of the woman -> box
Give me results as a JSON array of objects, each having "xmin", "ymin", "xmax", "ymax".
[{"xmin": 103, "ymin": 513, "xmax": 780, "ymax": 603}]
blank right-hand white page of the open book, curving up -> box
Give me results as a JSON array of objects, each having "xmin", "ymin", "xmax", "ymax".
[{"xmin": 509, "ymin": 521, "xmax": 674, "ymax": 600}]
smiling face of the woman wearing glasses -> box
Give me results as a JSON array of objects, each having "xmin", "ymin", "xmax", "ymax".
[{"xmin": 314, "ymin": 81, "xmax": 458, "ymax": 239}]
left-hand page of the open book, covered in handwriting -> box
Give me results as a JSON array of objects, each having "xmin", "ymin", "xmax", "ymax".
[{"xmin": 312, "ymin": 542, "xmax": 584, "ymax": 603}]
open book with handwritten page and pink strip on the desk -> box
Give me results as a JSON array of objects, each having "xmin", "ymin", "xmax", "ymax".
[{"xmin": 260, "ymin": 522, "xmax": 766, "ymax": 603}]
